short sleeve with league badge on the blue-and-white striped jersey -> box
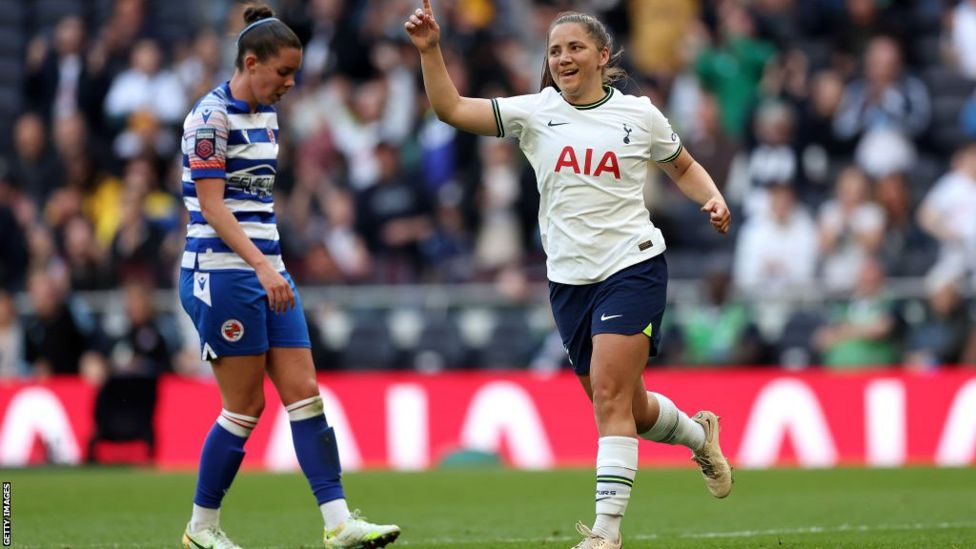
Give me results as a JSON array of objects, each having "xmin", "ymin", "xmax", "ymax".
[{"xmin": 183, "ymin": 108, "xmax": 228, "ymax": 180}]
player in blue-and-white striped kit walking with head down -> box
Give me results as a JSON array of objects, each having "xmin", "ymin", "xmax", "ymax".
[{"xmin": 180, "ymin": 6, "xmax": 400, "ymax": 549}]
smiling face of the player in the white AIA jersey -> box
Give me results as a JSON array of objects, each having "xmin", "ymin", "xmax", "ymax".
[{"xmin": 547, "ymin": 23, "xmax": 610, "ymax": 103}]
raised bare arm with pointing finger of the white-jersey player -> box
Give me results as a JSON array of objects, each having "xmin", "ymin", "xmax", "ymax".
[{"xmin": 403, "ymin": 0, "xmax": 498, "ymax": 135}]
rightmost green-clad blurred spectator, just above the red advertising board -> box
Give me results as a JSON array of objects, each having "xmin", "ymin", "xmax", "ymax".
[{"xmin": 814, "ymin": 259, "xmax": 900, "ymax": 369}]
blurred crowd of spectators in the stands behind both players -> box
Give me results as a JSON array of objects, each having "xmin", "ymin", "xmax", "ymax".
[{"xmin": 0, "ymin": 0, "xmax": 976, "ymax": 380}]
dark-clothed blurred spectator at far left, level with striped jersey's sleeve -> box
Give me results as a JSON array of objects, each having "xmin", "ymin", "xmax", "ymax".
[{"xmin": 7, "ymin": 113, "xmax": 63, "ymax": 204}]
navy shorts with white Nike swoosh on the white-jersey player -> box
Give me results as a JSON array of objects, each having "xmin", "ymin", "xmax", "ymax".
[{"xmin": 549, "ymin": 254, "xmax": 668, "ymax": 375}]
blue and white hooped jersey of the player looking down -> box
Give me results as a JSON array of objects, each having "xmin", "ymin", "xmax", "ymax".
[{"xmin": 181, "ymin": 82, "xmax": 285, "ymax": 272}]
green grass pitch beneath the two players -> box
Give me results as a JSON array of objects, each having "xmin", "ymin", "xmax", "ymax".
[{"xmin": 7, "ymin": 468, "xmax": 976, "ymax": 549}]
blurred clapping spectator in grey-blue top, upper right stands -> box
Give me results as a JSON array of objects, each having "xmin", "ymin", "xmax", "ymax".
[{"xmin": 834, "ymin": 36, "xmax": 932, "ymax": 177}]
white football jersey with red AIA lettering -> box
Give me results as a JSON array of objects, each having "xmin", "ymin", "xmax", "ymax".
[{"xmin": 491, "ymin": 87, "xmax": 681, "ymax": 284}]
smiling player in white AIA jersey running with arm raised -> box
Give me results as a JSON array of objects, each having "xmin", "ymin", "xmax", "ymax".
[{"xmin": 404, "ymin": 0, "xmax": 732, "ymax": 549}]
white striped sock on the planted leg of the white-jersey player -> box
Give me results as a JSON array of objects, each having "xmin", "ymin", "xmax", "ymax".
[{"xmin": 593, "ymin": 437, "xmax": 637, "ymax": 541}]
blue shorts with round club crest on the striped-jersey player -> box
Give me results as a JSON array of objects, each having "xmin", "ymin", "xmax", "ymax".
[{"xmin": 180, "ymin": 269, "xmax": 312, "ymax": 360}]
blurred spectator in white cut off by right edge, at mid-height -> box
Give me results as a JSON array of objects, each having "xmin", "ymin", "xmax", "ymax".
[{"xmin": 918, "ymin": 144, "xmax": 976, "ymax": 284}]
